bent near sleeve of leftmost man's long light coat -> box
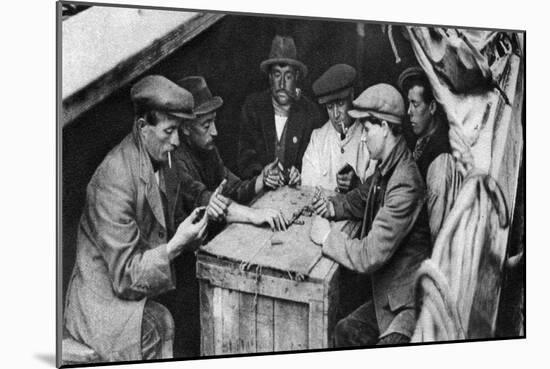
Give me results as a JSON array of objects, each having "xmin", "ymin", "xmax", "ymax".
[{"xmin": 83, "ymin": 168, "xmax": 175, "ymax": 300}]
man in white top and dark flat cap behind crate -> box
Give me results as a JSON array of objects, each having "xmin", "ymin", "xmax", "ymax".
[{"xmin": 302, "ymin": 64, "xmax": 374, "ymax": 193}]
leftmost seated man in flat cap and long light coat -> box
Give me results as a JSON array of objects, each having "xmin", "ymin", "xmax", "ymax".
[{"xmin": 64, "ymin": 75, "xmax": 207, "ymax": 361}]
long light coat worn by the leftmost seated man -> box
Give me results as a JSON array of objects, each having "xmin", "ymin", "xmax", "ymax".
[{"xmin": 64, "ymin": 128, "xmax": 181, "ymax": 361}]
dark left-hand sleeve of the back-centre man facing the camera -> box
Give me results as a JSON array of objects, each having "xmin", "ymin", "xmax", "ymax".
[{"xmin": 237, "ymin": 100, "xmax": 263, "ymax": 178}]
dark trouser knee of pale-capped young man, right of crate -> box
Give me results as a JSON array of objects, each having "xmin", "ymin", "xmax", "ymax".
[{"xmin": 334, "ymin": 301, "xmax": 380, "ymax": 347}]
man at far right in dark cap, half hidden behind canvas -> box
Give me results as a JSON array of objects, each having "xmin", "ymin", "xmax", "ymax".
[{"xmin": 398, "ymin": 67, "xmax": 462, "ymax": 242}]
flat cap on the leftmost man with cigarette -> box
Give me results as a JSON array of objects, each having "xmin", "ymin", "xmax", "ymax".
[{"xmin": 130, "ymin": 75, "xmax": 195, "ymax": 119}]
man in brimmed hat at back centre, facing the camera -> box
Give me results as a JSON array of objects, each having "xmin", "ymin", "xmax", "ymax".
[{"xmin": 237, "ymin": 35, "xmax": 321, "ymax": 185}]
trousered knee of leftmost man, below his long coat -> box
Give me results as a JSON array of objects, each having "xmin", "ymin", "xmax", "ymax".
[{"xmin": 141, "ymin": 300, "xmax": 174, "ymax": 360}]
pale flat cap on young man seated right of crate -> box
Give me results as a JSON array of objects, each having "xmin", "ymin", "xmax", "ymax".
[{"xmin": 348, "ymin": 83, "xmax": 405, "ymax": 124}]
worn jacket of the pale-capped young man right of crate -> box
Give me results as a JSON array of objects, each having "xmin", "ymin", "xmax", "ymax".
[{"xmin": 323, "ymin": 138, "xmax": 431, "ymax": 338}]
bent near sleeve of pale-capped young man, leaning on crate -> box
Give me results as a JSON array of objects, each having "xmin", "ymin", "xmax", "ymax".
[{"xmin": 323, "ymin": 171, "xmax": 424, "ymax": 273}]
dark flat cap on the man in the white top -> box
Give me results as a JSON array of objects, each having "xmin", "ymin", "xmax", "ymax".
[{"xmin": 312, "ymin": 64, "xmax": 357, "ymax": 104}]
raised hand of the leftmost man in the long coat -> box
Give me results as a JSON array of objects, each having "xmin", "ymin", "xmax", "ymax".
[{"xmin": 166, "ymin": 206, "xmax": 208, "ymax": 260}]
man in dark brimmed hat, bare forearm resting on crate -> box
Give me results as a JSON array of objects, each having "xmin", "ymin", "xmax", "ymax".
[{"xmin": 166, "ymin": 76, "xmax": 292, "ymax": 357}]
